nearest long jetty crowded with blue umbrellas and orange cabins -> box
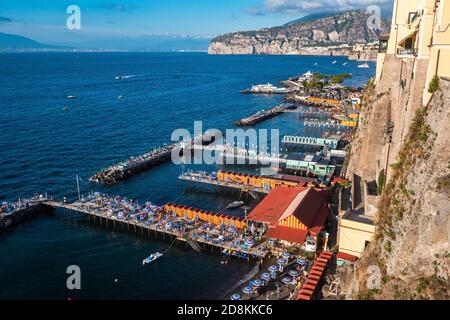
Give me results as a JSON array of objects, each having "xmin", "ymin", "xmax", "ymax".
[{"xmin": 9, "ymin": 192, "xmax": 269, "ymax": 259}]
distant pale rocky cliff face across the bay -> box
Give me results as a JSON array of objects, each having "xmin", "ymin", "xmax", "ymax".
[{"xmin": 208, "ymin": 11, "xmax": 387, "ymax": 54}]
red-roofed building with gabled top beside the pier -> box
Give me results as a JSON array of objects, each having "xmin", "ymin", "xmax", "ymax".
[{"xmin": 248, "ymin": 186, "xmax": 329, "ymax": 244}]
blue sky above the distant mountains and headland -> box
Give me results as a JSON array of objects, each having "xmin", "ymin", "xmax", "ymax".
[{"xmin": 0, "ymin": 0, "xmax": 392, "ymax": 44}]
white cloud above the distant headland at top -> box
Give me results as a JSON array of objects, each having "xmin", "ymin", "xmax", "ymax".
[{"xmin": 249, "ymin": 0, "xmax": 393, "ymax": 14}]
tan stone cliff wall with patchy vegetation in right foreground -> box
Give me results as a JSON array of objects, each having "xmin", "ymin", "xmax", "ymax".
[{"xmin": 347, "ymin": 56, "xmax": 450, "ymax": 299}]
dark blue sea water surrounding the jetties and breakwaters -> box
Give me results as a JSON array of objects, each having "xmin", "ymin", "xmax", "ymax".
[{"xmin": 0, "ymin": 53, "xmax": 375, "ymax": 299}]
